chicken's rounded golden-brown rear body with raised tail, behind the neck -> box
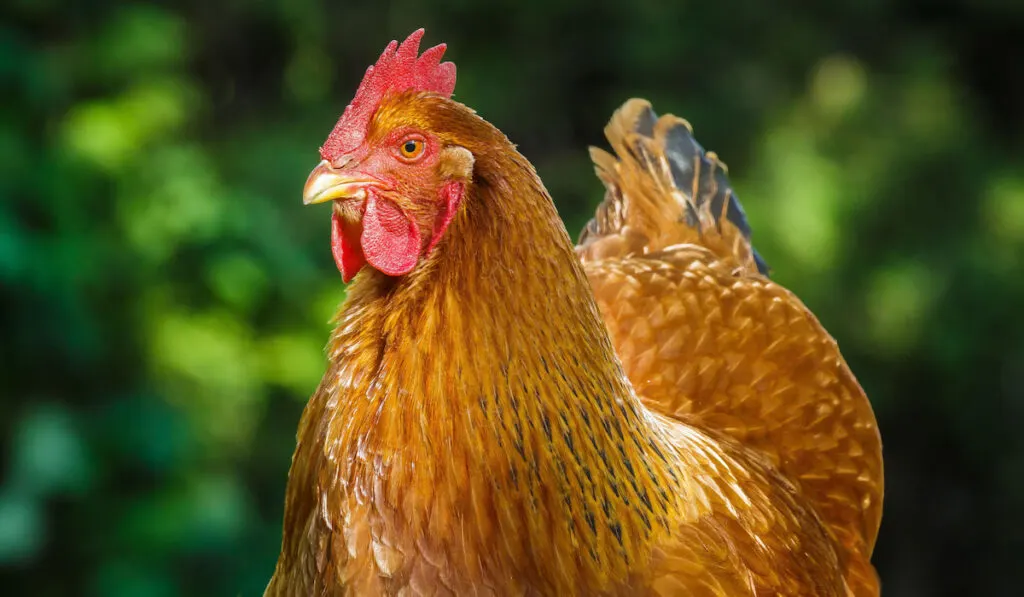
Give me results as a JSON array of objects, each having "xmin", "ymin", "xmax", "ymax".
[{"xmin": 578, "ymin": 99, "xmax": 883, "ymax": 595}]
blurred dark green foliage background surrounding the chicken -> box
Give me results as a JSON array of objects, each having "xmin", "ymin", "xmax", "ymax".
[{"xmin": 0, "ymin": 0, "xmax": 1024, "ymax": 597}]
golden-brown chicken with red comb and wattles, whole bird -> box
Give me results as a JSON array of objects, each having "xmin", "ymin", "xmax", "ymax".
[{"xmin": 265, "ymin": 30, "xmax": 882, "ymax": 596}]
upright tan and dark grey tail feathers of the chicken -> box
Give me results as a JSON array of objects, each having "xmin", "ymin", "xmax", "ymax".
[{"xmin": 579, "ymin": 99, "xmax": 768, "ymax": 274}]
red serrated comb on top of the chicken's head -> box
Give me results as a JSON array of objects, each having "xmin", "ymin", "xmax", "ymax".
[{"xmin": 321, "ymin": 29, "xmax": 455, "ymax": 161}]
